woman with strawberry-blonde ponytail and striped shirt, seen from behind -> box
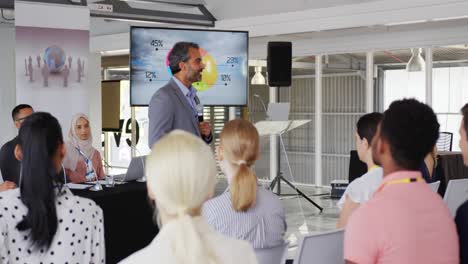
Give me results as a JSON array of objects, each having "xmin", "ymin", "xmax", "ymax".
[{"xmin": 202, "ymin": 119, "xmax": 286, "ymax": 248}]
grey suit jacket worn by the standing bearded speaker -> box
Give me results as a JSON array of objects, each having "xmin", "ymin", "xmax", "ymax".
[{"xmin": 148, "ymin": 79, "xmax": 213, "ymax": 148}]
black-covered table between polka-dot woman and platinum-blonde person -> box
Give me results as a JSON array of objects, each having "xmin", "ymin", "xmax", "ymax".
[{"xmin": 72, "ymin": 182, "xmax": 159, "ymax": 264}]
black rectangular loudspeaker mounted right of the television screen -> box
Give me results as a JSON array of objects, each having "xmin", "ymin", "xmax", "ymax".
[{"xmin": 267, "ymin": 42, "xmax": 292, "ymax": 87}]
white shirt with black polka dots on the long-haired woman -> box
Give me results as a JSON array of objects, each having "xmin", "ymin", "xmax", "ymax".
[{"xmin": 0, "ymin": 187, "xmax": 105, "ymax": 264}]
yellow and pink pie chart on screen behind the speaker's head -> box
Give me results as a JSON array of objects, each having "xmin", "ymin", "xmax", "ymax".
[{"xmin": 166, "ymin": 48, "xmax": 218, "ymax": 92}]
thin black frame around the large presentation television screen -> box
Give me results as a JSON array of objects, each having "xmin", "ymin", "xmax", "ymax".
[{"xmin": 128, "ymin": 26, "xmax": 250, "ymax": 107}]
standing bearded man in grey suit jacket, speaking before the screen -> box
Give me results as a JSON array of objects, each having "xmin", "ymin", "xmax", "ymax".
[{"xmin": 148, "ymin": 42, "xmax": 213, "ymax": 148}]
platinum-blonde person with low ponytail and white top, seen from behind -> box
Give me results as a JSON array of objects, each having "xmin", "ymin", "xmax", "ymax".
[{"xmin": 117, "ymin": 130, "xmax": 256, "ymax": 264}]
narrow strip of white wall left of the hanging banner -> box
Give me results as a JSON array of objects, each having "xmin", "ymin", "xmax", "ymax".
[{"xmin": 0, "ymin": 27, "xmax": 17, "ymax": 145}]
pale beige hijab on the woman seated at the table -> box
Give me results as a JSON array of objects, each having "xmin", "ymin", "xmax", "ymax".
[{"xmin": 63, "ymin": 113, "xmax": 96, "ymax": 170}]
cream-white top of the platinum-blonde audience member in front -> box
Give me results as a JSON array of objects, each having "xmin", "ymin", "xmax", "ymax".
[{"xmin": 120, "ymin": 217, "xmax": 257, "ymax": 264}]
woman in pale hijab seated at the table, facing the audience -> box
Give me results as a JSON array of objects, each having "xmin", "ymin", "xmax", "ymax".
[{"xmin": 63, "ymin": 114, "xmax": 105, "ymax": 183}]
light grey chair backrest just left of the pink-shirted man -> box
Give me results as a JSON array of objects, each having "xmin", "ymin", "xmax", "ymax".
[{"xmin": 294, "ymin": 229, "xmax": 344, "ymax": 264}]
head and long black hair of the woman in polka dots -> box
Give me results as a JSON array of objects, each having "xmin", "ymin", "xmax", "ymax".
[{"xmin": 15, "ymin": 112, "xmax": 65, "ymax": 248}]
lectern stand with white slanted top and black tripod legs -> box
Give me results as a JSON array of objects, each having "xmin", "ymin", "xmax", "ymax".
[{"xmin": 255, "ymin": 120, "xmax": 323, "ymax": 212}]
